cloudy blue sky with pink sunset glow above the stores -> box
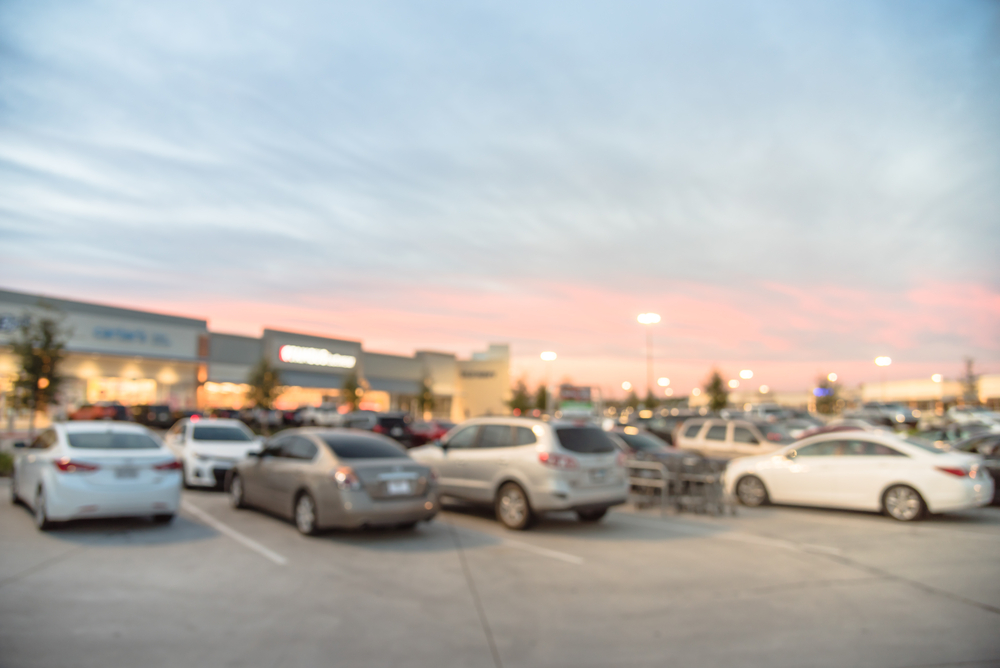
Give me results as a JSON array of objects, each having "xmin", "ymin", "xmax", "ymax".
[{"xmin": 0, "ymin": 0, "xmax": 1000, "ymax": 395}]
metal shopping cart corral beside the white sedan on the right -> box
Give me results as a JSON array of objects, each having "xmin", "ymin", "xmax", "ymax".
[{"xmin": 625, "ymin": 453, "xmax": 736, "ymax": 515}]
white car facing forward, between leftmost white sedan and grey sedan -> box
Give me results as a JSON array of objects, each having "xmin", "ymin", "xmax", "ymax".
[{"xmin": 164, "ymin": 416, "xmax": 261, "ymax": 488}]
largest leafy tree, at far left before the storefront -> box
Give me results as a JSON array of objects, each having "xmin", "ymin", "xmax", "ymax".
[{"xmin": 11, "ymin": 316, "xmax": 67, "ymax": 438}]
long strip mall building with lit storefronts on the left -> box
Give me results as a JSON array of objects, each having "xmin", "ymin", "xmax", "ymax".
[{"xmin": 0, "ymin": 290, "xmax": 510, "ymax": 420}]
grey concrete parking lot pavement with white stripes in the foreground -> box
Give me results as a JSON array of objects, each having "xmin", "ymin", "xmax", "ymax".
[{"xmin": 0, "ymin": 481, "xmax": 1000, "ymax": 667}]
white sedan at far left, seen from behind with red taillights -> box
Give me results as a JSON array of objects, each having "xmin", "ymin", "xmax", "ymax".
[{"xmin": 10, "ymin": 421, "xmax": 181, "ymax": 530}]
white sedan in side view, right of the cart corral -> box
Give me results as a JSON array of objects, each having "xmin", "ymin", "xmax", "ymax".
[{"xmin": 726, "ymin": 431, "xmax": 994, "ymax": 522}]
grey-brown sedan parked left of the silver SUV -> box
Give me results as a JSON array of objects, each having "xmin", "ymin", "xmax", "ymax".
[{"xmin": 227, "ymin": 429, "xmax": 439, "ymax": 534}]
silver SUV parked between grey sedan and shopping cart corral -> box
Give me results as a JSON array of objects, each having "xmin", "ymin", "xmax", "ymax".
[{"xmin": 410, "ymin": 418, "xmax": 628, "ymax": 529}]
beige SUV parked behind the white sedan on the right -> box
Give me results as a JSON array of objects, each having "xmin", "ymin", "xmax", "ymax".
[{"xmin": 674, "ymin": 418, "xmax": 795, "ymax": 458}]
